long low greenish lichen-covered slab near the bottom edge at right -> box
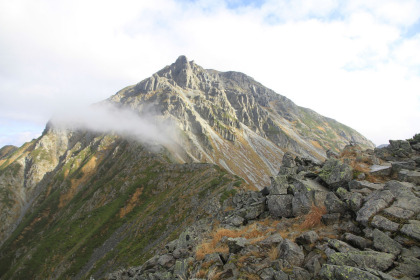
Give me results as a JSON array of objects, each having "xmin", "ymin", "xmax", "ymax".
[{"xmin": 328, "ymin": 251, "xmax": 395, "ymax": 271}]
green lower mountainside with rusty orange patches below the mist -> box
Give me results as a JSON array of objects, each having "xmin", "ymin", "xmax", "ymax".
[{"xmin": 0, "ymin": 129, "xmax": 242, "ymax": 279}]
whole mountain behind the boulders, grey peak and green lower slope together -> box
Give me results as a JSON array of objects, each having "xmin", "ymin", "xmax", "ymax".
[{"xmin": 0, "ymin": 56, "xmax": 373, "ymax": 279}]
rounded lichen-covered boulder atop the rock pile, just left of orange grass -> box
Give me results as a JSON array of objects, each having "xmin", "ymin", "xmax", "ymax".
[{"xmin": 319, "ymin": 159, "xmax": 353, "ymax": 190}]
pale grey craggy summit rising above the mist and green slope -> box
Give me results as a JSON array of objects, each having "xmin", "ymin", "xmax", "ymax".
[{"xmin": 108, "ymin": 56, "xmax": 373, "ymax": 187}]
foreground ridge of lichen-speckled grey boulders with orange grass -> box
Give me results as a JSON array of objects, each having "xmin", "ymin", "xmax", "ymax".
[{"xmin": 106, "ymin": 134, "xmax": 420, "ymax": 280}]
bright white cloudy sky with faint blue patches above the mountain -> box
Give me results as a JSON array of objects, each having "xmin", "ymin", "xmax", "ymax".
[{"xmin": 0, "ymin": 0, "xmax": 420, "ymax": 147}]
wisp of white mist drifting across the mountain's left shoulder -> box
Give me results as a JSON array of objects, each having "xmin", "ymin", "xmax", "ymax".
[{"xmin": 51, "ymin": 102, "xmax": 176, "ymax": 145}]
